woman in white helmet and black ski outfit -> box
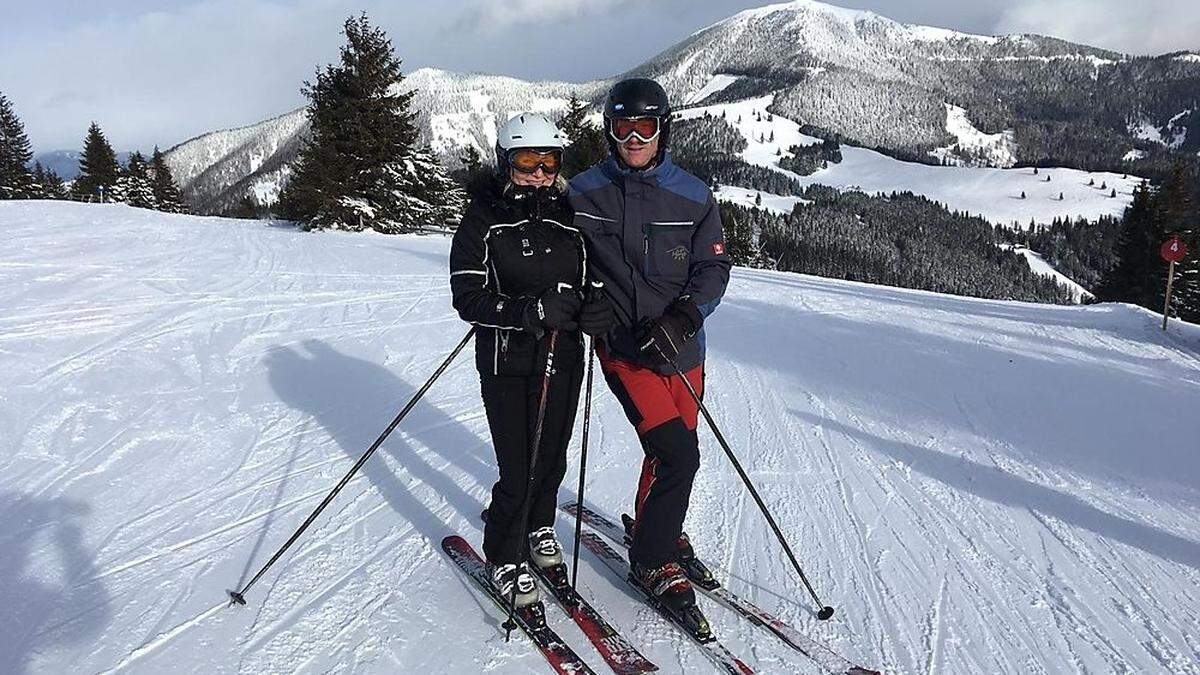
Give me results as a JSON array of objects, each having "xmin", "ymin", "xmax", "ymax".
[{"xmin": 450, "ymin": 113, "xmax": 613, "ymax": 607}]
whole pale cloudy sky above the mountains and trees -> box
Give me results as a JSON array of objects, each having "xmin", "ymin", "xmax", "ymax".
[{"xmin": 0, "ymin": 0, "xmax": 1200, "ymax": 153}]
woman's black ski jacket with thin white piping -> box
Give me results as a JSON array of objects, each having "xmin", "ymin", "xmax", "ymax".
[{"xmin": 450, "ymin": 178, "xmax": 587, "ymax": 376}]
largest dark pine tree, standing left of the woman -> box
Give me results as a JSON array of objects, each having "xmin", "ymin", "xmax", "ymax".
[{"xmin": 278, "ymin": 14, "xmax": 466, "ymax": 233}]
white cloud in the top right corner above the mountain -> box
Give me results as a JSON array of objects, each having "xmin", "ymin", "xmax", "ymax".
[{"xmin": 997, "ymin": 0, "xmax": 1200, "ymax": 54}]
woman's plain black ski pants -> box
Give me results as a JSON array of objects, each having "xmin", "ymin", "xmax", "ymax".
[{"xmin": 479, "ymin": 362, "xmax": 583, "ymax": 565}]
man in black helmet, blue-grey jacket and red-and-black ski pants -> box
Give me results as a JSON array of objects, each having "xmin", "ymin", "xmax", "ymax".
[{"xmin": 570, "ymin": 78, "xmax": 730, "ymax": 614}]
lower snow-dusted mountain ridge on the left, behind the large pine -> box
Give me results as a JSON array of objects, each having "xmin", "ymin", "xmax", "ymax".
[{"xmin": 166, "ymin": 68, "xmax": 604, "ymax": 213}]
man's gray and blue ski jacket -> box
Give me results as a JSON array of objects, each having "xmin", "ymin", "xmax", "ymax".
[{"xmin": 570, "ymin": 153, "xmax": 731, "ymax": 374}]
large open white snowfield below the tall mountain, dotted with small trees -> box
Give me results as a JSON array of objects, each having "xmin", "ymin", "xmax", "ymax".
[{"xmin": 680, "ymin": 96, "xmax": 1141, "ymax": 226}]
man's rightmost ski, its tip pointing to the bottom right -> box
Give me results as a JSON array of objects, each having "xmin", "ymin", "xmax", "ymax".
[{"xmin": 560, "ymin": 502, "xmax": 880, "ymax": 675}]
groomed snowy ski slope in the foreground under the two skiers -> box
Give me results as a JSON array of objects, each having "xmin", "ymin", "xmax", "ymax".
[{"xmin": 0, "ymin": 202, "xmax": 1200, "ymax": 674}]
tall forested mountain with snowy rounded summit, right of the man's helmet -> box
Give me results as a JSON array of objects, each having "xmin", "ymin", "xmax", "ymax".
[{"xmin": 626, "ymin": 0, "xmax": 1200, "ymax": 168}]
